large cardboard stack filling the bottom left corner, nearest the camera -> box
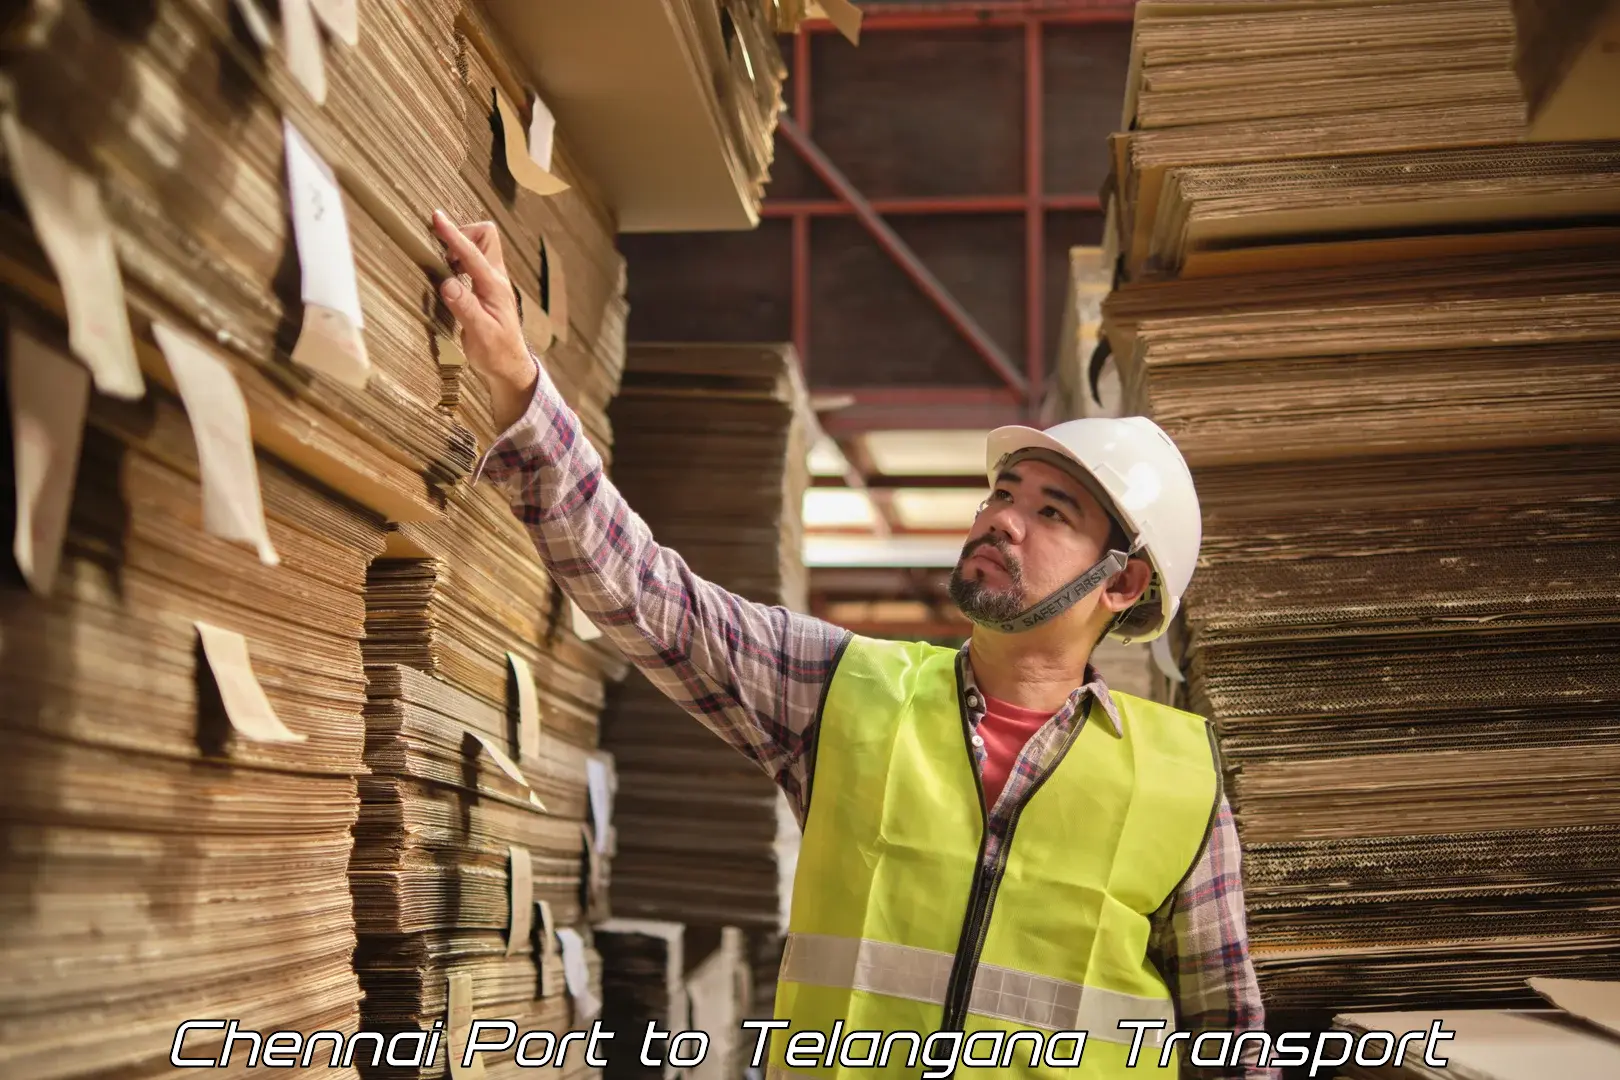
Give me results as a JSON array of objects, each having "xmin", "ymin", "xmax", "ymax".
[{"xmin": 0, "ymin": 307, "xmax": 384, "ymax": 1080}]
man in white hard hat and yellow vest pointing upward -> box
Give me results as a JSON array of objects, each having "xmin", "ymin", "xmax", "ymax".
[{"xmin": 434, "ymin": 214, "xmax": 1277, "ymax": 1080}]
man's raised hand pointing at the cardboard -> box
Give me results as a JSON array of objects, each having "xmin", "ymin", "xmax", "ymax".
[{"xmin": 433, "ymin": 210, "xmax": 538, "ymax": 431}]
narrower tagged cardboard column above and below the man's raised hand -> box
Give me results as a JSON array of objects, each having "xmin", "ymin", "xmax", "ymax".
[{"xmin": 355, "ymin": 6, "xmax": 627, "ymax": 1075}]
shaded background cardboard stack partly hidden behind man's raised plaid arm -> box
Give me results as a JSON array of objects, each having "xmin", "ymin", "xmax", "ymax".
[{"xmin": 603, "ymin": 345, "xmax": 813, "ymax": 929}]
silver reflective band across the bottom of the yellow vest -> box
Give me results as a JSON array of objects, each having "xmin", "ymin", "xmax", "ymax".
[{"xmin": 781, "ymin": 934, "xmax": 1176, "ymax": 1046}]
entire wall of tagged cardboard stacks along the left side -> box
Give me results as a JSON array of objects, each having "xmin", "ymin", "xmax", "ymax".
[{"xmin": 0, "ymin": 0, "xmax": 624, "ymax": 1078}]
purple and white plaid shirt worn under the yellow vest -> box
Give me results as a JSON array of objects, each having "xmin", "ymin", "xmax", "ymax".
[{"xmin": 475, "ymin": 366, "xmax": 1281, "ymax": 1080}]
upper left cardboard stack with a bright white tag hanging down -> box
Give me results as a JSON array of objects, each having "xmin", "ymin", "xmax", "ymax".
[{"xmin": 8, "ymin": 0, "xmax": 475, "ymax": 513}]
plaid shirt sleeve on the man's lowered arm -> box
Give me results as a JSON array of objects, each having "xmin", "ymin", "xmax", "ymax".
[{"xmin": 1152, "ymin": 797, "xmax": 1283, "ymax": 1080}]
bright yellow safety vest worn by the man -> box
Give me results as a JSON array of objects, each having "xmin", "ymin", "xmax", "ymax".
[{"xmin": 766, "ymin": 636, "xmax": 1220, "ymax": 1080}]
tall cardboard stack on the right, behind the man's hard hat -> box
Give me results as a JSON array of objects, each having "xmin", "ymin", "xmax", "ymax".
[{"xmin": 1103, "ymin": 0, "xmax": 1620, "ymax": 1012}]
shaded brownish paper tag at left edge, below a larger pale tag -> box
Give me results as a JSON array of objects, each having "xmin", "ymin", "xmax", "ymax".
[{"xmin": 6, "ymin": 327, "xmax": 91, "ymax": 596}]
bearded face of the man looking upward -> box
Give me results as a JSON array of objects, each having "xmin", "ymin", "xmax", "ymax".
[{"xmin": 951, "ymin": 460, "xmax": 1113, "ymax": 622}]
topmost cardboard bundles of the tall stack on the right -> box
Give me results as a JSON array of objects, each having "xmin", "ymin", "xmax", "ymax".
[{"xmin": 1115, "ymin": 0, "xmax": 1620, "ymax": 279}]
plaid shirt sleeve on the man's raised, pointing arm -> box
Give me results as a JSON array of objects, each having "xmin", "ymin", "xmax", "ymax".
[{"xmin": 473, "ymin": 363, "xmax": 847, "ymax": 808}]
